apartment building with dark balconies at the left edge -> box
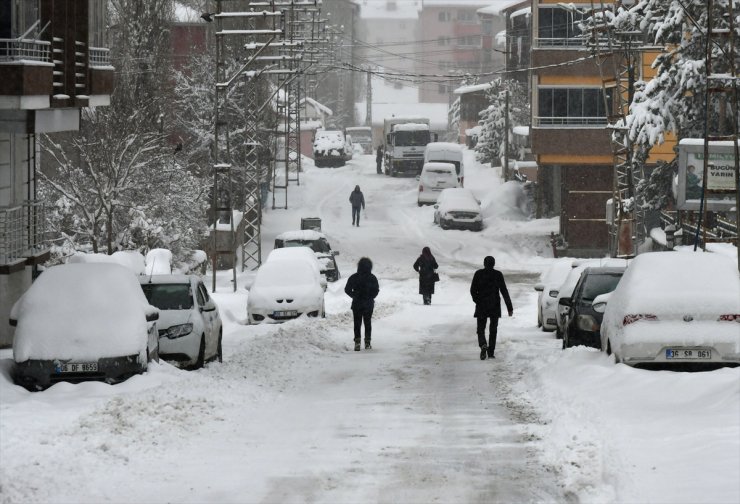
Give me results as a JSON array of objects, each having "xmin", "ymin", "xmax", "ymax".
[{"xmin": 0, "ymin": 0, "xmax": 113, "ymax": 347}]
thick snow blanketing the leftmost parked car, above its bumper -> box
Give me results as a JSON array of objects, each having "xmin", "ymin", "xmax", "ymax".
[{"xmin": 11, "ymin": 263, "xmax": 154, "ymax": 362}]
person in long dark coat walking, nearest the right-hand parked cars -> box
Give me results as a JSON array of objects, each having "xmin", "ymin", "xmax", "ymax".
[{"xmin": 470, "ymin": 256, "xmax": 514, "ymax": 360}]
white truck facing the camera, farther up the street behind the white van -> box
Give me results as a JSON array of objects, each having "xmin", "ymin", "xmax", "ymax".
[{"xmin": 383, "ymin": 117, "xmax": 437, "ymax": 177}]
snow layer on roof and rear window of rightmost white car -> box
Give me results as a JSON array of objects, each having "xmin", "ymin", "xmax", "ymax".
[{"xmin": 609, "ymin": 252, "xmax": 740, "ymax": 315}]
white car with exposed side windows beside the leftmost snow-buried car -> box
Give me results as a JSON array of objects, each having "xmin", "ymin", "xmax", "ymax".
[{"xmin": 139, "ymin": 275, "xmax": 223, "ymax": 369}]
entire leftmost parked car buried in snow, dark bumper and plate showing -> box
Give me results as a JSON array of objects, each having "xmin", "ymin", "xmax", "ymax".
[{"xmin": 10, "ymin": 263, "xmax": 159, "ymax": 390}]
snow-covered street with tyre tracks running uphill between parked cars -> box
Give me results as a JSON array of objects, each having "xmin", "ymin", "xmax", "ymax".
[{"xmin": 0, "ymin": 151, "xmax": 740, "ymax": 503}]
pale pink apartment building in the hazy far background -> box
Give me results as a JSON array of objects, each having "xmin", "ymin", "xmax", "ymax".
[{"xmin": 416, "ymin": 0, "xmax": 495, "ymax": 103}]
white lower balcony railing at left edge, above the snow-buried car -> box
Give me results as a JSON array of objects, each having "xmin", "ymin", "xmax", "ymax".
[{"xmin": 0, "ymin": 201, "xmax": 48, "ymax": 265}]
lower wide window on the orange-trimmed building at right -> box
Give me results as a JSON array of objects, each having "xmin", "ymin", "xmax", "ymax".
[{"xmin": 537, "ymin": 87, "xmax": 612, "ymax": 126}]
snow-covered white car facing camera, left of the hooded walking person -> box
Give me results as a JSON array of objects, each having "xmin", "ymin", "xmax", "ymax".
[{"xmin": 247, "ymin": 251, "xmax": 326, "ymax": 324}]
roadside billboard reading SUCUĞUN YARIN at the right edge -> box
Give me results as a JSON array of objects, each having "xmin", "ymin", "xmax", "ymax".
[{"xmin": 674, "ymin": 138, "xmax": 736, "ymax": 212}]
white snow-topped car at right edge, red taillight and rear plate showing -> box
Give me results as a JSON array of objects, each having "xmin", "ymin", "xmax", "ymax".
[{"xmin": 595, "ymin": 252, "xmax": 740, "ymax": 369}]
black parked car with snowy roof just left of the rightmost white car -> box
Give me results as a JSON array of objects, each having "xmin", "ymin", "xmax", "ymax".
[{"xmin": 560, "ymin": 267, "xmax": 625, "ymax": 349}]
